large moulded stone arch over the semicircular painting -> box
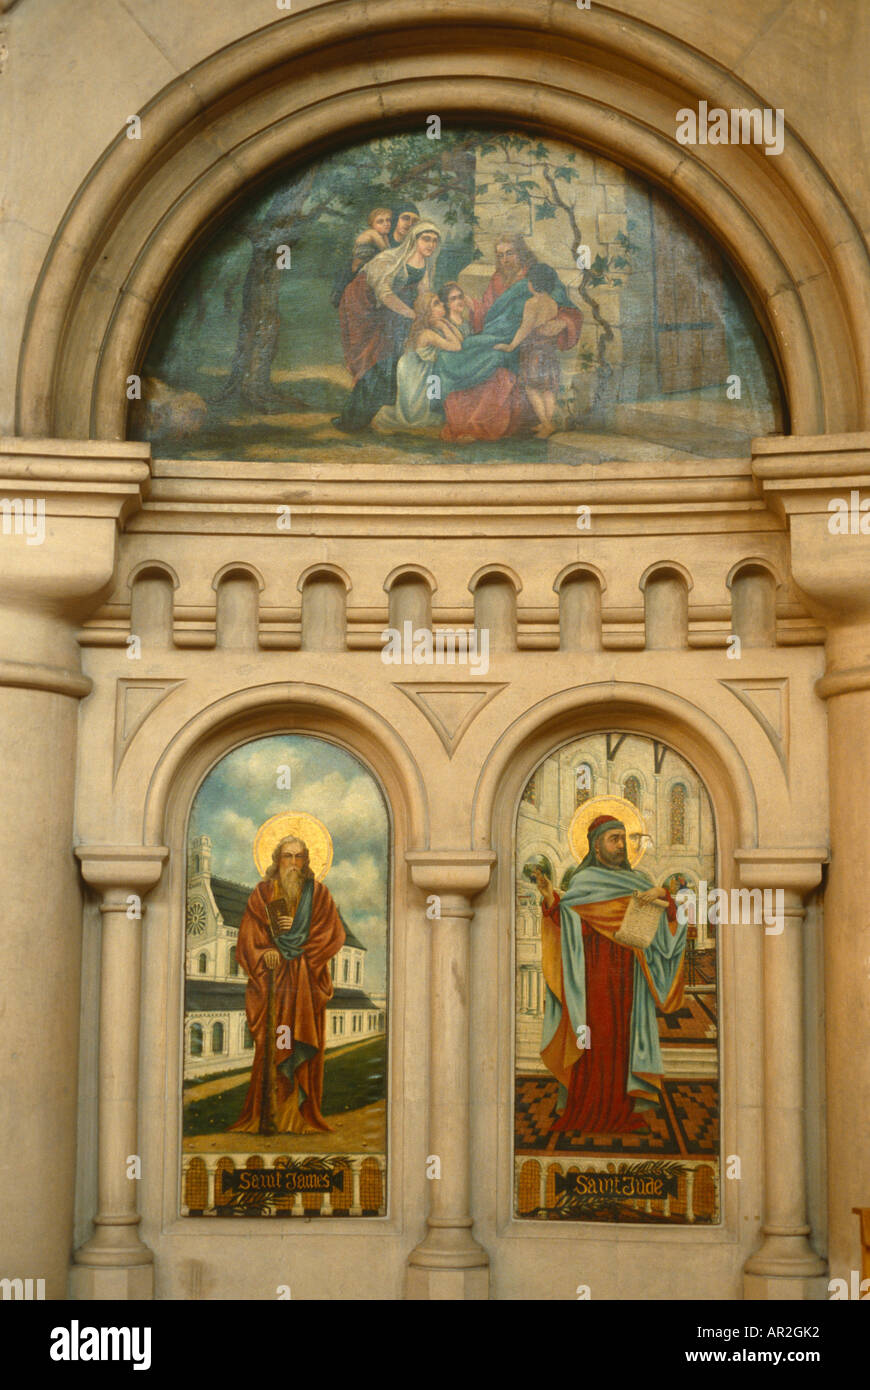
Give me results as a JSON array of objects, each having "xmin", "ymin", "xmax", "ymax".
[{"xmin": 17, "ymin": 0, "xmax": 870, "ymax": 439}]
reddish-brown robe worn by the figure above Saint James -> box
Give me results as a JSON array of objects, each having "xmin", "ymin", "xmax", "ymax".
[{"xmin": 232, "ymin": 880, "xmax": 345, "ymax": 1134}]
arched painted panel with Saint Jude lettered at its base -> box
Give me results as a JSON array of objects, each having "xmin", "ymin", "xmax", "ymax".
[{"xmin": 514, "ymin": 731, "xmax": 720, "ymax": 1225}]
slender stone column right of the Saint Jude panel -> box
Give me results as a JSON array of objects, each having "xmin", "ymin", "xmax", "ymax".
[{"xmin": 732, "ymin": 849, "xmax": 827, "ymax": 1300}]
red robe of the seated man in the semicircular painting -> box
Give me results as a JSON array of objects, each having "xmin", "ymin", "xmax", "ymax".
[{"xmin": 441, "ymin": 270, "xmax": 582, "ymax": 439}]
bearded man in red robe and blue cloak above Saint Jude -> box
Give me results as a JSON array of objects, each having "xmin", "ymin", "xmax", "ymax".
[{"xmin": 532, "ymin": 816, "xmax": 687, "ymax": 1134}]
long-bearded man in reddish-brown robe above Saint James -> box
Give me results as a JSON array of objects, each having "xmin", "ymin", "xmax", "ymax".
[{"xmin": 232, "ymin": 835, "xmax": 345, "ymax": 1134}]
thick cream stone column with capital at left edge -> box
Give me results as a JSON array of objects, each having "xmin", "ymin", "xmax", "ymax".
[{"xmin": 0, "ymin": 439, "xmax": 149, "ymax": 1298}]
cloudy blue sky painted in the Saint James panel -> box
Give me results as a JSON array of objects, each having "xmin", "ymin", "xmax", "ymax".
[{"xmin": 189, "ymin": 734, "xmax": 389, "ymax": 994}]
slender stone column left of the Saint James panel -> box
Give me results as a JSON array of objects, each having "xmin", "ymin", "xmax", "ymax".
[{"xmin": 71, "ymin": 845, "xmax": 170, "ymax": 1298}]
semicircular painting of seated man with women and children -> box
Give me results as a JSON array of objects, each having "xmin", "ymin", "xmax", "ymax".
[{"xmin": 129, "ymin": 128, "xmax": 785, "ymax": 464}]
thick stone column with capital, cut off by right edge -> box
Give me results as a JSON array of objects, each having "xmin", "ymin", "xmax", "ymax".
[{"xmin": 752, "ymin": 434, "xmax": 870, "ymax": 1282}]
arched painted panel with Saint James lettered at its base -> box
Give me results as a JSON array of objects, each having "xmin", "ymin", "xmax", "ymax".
[{"xmin": 181, "ymin": 735, "xmax": 389, "ymax": 1218}]
